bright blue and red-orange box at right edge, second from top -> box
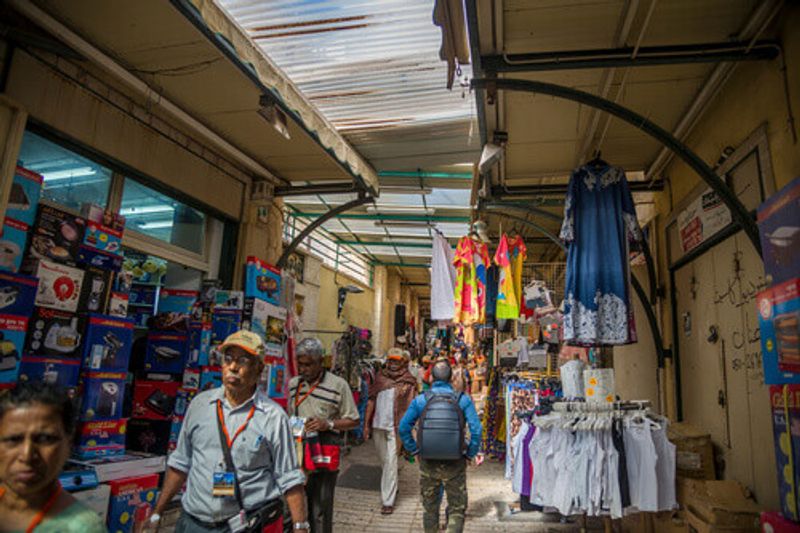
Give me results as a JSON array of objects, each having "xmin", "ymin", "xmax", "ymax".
[{"xmin": 756, "ymin": 278, "xmax": 800, "ymax": 385}]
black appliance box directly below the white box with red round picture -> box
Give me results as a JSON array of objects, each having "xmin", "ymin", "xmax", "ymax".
[{"xmin": 25, "ymin": 307, "xmax": 83, "ymax": 359}]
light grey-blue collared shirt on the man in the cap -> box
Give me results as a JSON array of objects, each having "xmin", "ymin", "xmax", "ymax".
[{"xmin": 167, "ymin": 387, "xmax": 305, "ymax": 522}]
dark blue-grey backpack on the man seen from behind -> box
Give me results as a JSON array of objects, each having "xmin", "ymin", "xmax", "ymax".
[{"xmin": 417, "ymin": 391, "xmax": 464, "ymax": 461}]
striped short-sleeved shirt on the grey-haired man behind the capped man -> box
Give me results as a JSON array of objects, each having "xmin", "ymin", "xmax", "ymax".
[{"xmin": 289, "ymin": 370, "xmax": 359, "ymax": 420}]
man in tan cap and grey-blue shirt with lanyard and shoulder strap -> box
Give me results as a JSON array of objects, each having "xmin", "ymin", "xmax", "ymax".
[{"xmin": 150, "ymin": 330, "xmax": 309, "ymax": 533}]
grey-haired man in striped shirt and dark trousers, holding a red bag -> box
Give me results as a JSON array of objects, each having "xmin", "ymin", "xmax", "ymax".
[{"xmin": 288, "ymin": 338, "xmax": 359, "ymax": 533}]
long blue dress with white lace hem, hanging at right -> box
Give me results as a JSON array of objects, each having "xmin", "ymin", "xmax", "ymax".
[{"xmin": 560, "ymin": 165, "xmax": 642, "ymax": 346}]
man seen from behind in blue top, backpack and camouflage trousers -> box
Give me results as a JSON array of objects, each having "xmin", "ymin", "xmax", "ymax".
[{"xmin": 398, "ymin": 359, "xmax": 482, "ymax": 533}]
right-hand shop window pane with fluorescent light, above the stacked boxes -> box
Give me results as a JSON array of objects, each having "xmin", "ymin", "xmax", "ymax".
[{"xmin": 120, "ymin": 179, "xmax": 206, "ymax": 254}]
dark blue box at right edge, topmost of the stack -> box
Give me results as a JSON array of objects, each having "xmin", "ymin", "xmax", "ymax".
[{"xmin": 758, "ymin": 177, "xmax": 800, "ymax": 284}]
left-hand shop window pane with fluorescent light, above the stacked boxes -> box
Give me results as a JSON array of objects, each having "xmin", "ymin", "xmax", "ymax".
[{"xmin": 19, "ymin": 131, "xmax": 112, "ymax": 211}]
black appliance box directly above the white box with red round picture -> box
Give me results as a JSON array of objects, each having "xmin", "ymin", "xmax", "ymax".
[{"xmin": 26, "ymin": 205, "xmax": 86, "ymax": 271}]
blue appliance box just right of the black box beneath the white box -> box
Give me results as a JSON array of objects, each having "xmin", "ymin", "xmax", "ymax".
[{"xmin": 83, "ymin": 315, "xmax": 133, "ymax": 372}]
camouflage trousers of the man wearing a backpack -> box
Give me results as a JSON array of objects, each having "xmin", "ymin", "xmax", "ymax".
[{"xmin": 419, "ymin": 459, "xmax": 467, "ymax": 533}]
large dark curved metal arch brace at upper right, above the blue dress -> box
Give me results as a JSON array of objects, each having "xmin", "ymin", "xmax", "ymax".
[{"xmin": 471, "ymin": 78, "xmax": 761, "ymax": 255}]
